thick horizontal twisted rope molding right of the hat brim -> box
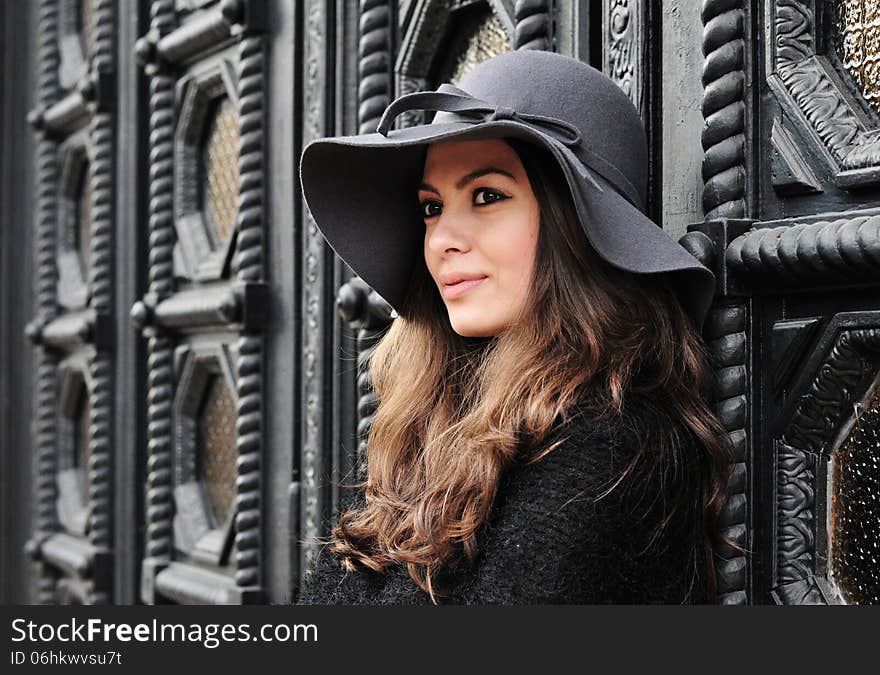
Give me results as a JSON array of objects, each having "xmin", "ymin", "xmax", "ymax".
[{"xmin": 725, "ymin": 215, "xmax": 880, "ymax": 284}]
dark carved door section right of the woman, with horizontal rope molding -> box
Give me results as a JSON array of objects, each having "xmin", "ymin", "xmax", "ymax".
[{"xmin": 694, "ymin": 0, "xmax": 880, "ymax": 604}]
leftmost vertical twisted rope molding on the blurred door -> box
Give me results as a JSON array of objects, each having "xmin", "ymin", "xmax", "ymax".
[{"xmin": 28, "ymin": 0, "xmax": 62, "ymax": 604}]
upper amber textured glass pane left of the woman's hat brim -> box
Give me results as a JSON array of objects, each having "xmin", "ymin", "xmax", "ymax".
[{"xmin": 202, "ymin": 98, "xmax": 238, "ymax": 255}]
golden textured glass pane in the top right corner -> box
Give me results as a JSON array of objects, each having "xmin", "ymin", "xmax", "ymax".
[{"xmin": 833, "ymin": 0, "xmax": 880, "ymax": 114}]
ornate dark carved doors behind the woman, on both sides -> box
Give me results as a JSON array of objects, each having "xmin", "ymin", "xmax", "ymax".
[{"xmin": 8, "ymin": 0, "xmax": 880, "ymax": 603}]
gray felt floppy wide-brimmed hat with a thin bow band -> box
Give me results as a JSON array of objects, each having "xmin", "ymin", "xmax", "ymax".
[{"xmin": 300, "ymin": 50, "xmax": 715, "ymax": 328}]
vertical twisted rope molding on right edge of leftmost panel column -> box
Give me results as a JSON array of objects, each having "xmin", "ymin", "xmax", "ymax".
[{"xmin": 87, "ymin": 0, "xmax": 116, "ymax": 604}]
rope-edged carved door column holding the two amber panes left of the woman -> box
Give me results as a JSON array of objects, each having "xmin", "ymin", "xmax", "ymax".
[{"xmin": 131, "ymin": 0, "xmax": 267, "ymax": 604}]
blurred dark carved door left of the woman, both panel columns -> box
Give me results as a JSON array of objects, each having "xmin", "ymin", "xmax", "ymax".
[{"xmin": 19, "ymin": 0, "xmax": 357, "ymax": 603}]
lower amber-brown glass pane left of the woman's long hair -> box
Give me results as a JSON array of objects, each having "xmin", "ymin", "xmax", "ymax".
[{"xmin": 198, "ymin": 375, "xmax": 236, "ymax": 525}]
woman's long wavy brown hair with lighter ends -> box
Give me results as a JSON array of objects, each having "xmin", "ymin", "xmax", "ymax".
[{"xmin": 331, "ymin": 139, "xmax": 730, "ymax": 603}]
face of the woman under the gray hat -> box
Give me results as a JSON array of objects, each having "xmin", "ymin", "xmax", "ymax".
[{"xmin": 419, "ymin": 139, "xmax": 540, "ymax": 337}]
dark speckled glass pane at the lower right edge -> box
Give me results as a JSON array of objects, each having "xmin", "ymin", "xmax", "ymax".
[{"xmin": 830, "ymin": 382, "xmax": 880, "ymax": 604}]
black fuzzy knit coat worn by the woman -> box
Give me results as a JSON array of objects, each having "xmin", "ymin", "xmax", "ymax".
[{"xmin": 300, "ymin": 399, "xmax": 707, "ymax": 605}]
